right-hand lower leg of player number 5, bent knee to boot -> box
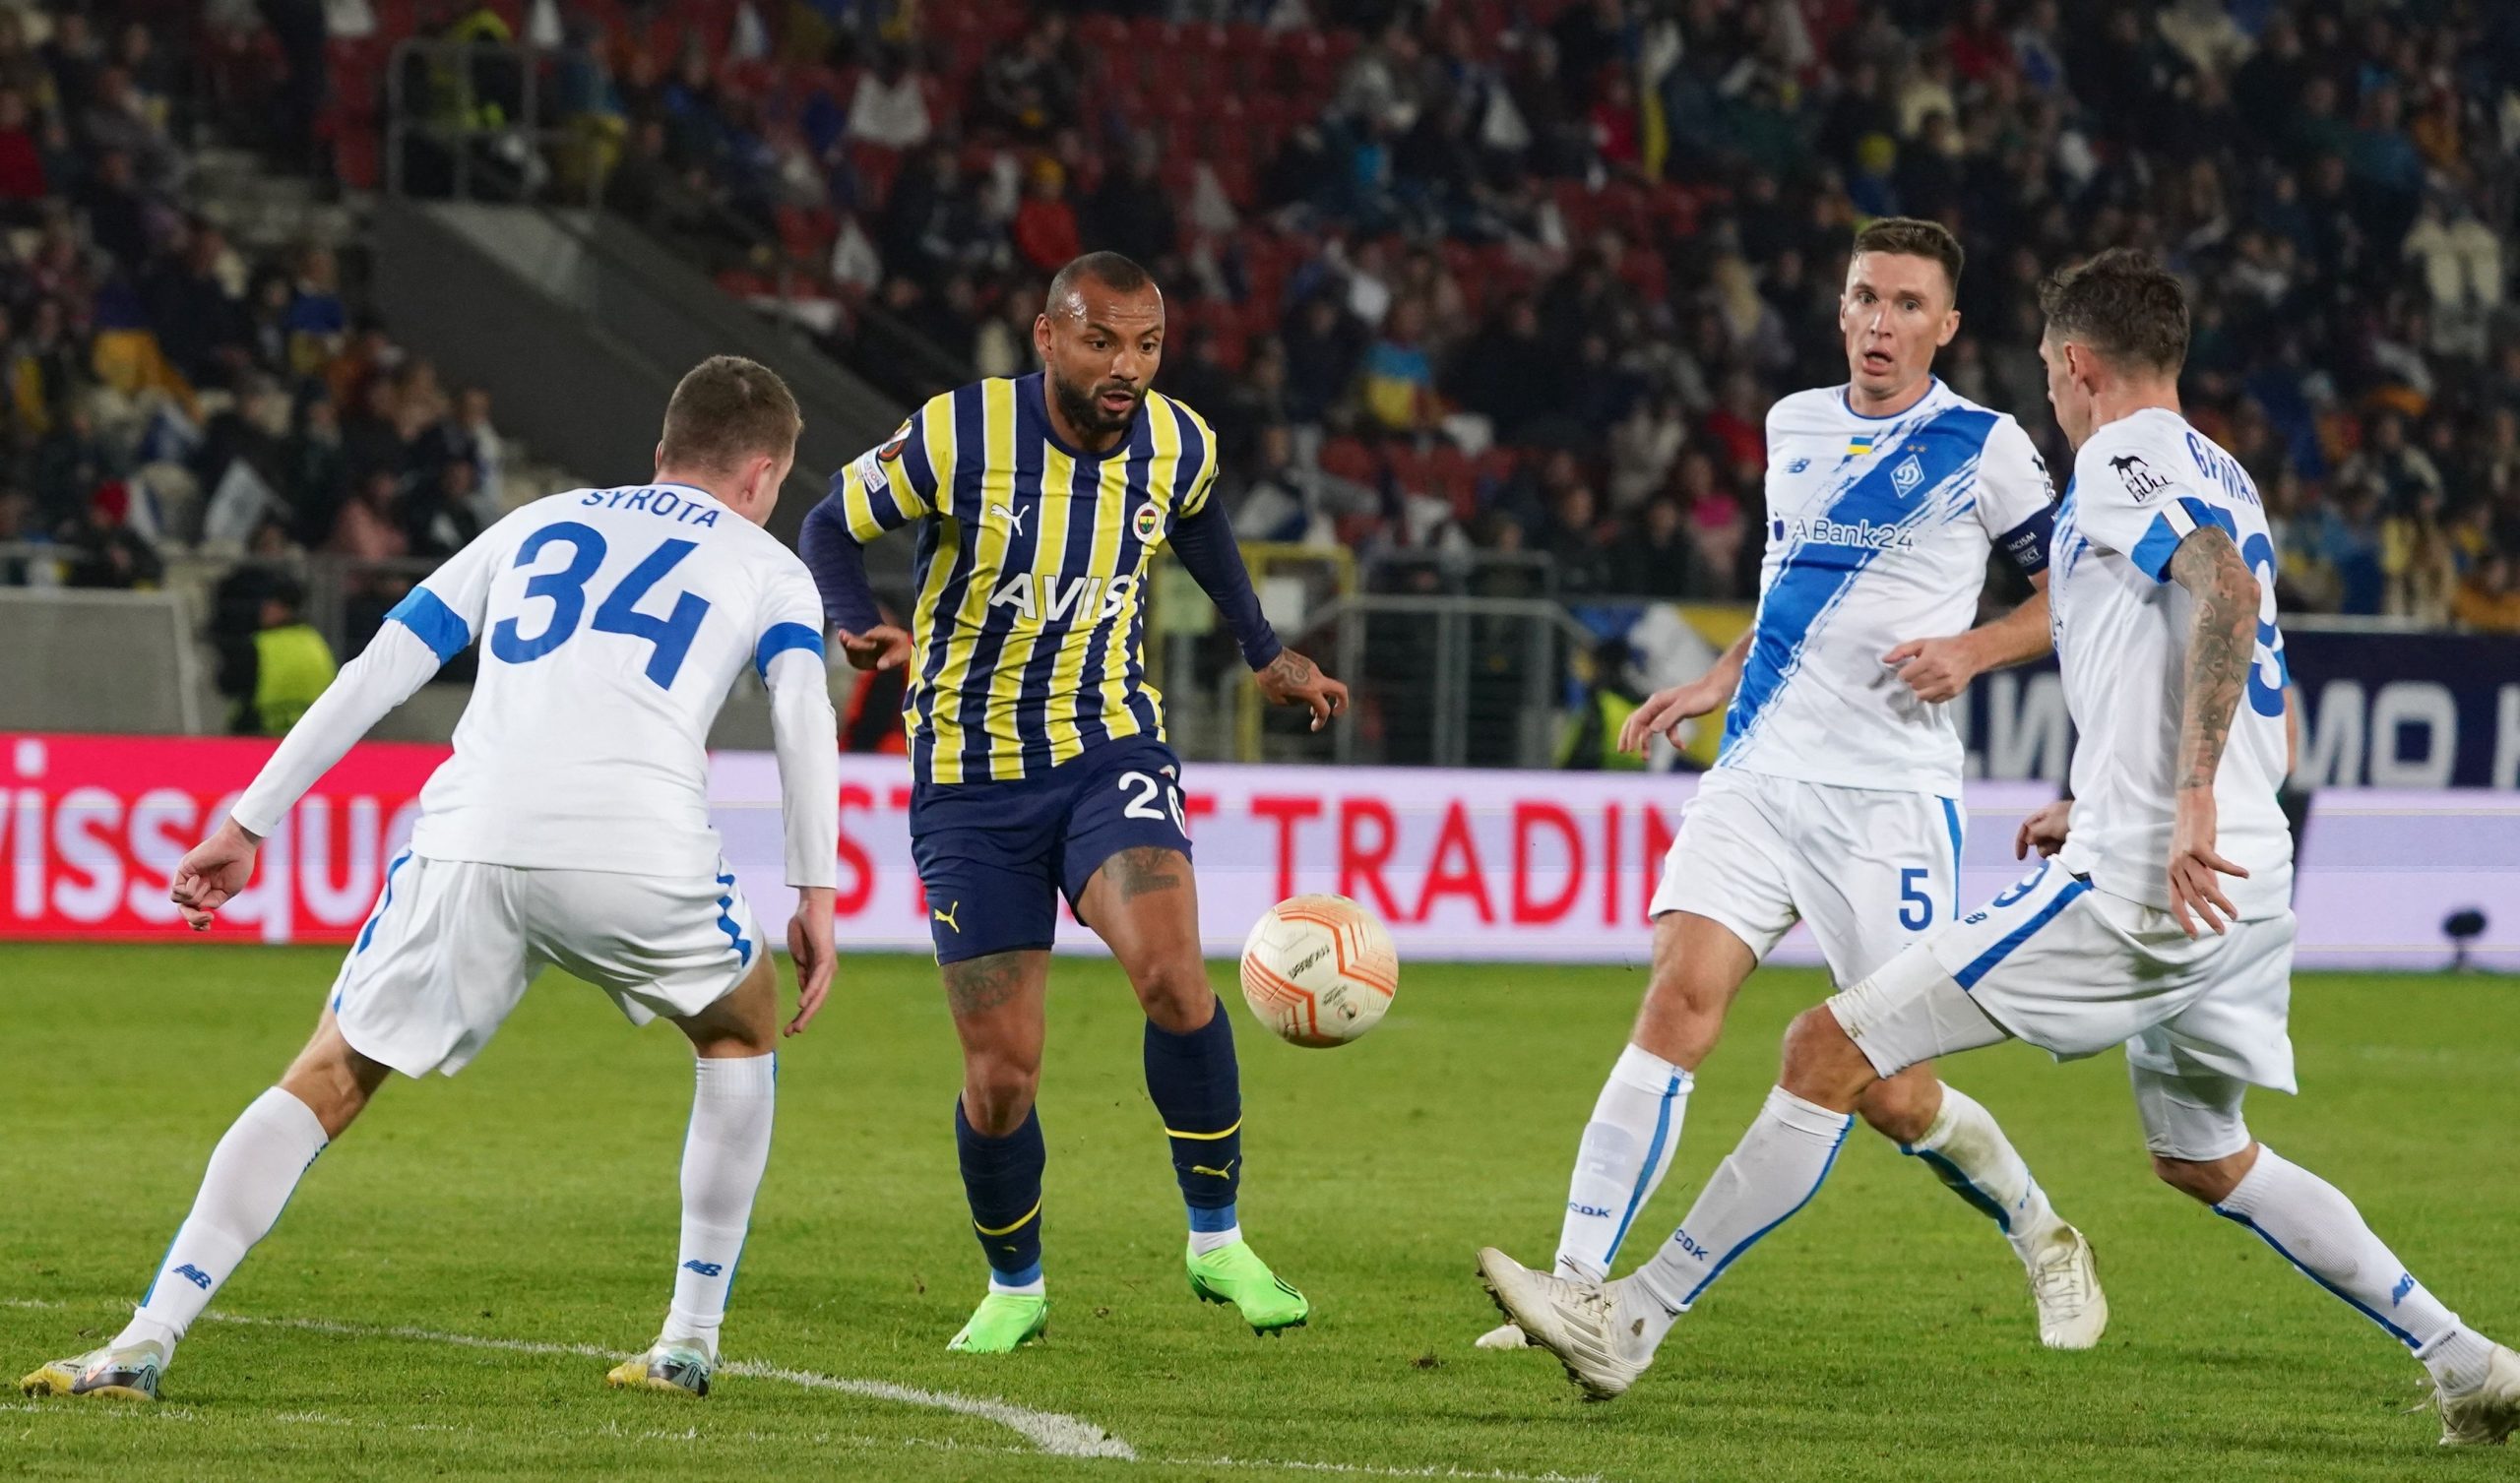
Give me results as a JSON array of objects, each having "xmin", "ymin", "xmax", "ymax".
[{"xmin": 1855, "ymin": 1065, "xmax": 2110, "ymax": 1349}]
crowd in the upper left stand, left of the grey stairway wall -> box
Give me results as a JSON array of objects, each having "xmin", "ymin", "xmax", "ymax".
[{"xmin": 0, "ymin": 8, "xmax": 501, "ymax": 629}]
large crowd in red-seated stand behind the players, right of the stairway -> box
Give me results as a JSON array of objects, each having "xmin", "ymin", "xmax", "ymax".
[{"xmin": 496, "ymin": 0, "xmax": 2520, "ymax": 627}]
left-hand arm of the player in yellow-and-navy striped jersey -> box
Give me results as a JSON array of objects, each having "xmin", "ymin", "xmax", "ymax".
[{"xmin": 796, "ymin": 407, "xmax": 953, "ymax": 670}]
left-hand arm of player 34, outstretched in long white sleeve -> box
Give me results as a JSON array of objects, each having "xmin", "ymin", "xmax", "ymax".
[{"xmin": 169, "ymin": 511, "xmax": 507, "ymax": 932}]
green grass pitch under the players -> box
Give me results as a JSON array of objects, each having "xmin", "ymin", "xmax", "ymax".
[{"xmin": 0, "ymin": 944, "xmax": 2520, "ymax": 1483}]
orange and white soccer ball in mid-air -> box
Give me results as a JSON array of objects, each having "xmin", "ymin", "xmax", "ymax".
[{"xmin": 1242, "ymin": 896, "xmax": 1401, "ymax": 1045}]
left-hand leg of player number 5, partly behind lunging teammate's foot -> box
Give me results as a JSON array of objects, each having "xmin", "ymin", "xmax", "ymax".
[{"xmin": 1480, "ymin": 911, "xmax": 1759, "ymax": 1349}]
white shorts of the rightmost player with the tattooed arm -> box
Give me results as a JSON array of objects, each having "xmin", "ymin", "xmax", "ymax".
[{"xmin": 1830, "ymin": 861, "xmax": 2294, "ymax": 1158}]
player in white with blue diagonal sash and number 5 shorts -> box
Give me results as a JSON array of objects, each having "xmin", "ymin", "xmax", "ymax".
[{"xmin": 1480, "ymin": 219, "xmax": 2110, "ymax": 1349}]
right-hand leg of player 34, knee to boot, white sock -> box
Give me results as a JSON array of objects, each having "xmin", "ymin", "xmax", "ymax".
[{"xmin": 604, "ymin": 955, "xmax": 779, "ymax": 1397}]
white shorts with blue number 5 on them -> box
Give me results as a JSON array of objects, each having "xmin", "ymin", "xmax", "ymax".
[{"xmin": 1651, "ymin": 768, "xmax": 1966, "ymax": 984}]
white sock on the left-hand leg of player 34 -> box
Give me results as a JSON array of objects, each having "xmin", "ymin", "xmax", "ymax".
[{"xmin": 113, "ymin": 1087, "xmax": 325, "ymax": 1357}]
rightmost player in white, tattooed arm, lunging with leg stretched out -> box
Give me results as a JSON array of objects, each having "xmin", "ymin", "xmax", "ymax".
[{"xmin": 1480, "ymin": 249, "xmax": 2520, "ymax": 1446}]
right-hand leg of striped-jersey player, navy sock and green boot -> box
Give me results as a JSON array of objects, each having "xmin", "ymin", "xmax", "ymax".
[{"xmin": 1079, "ymin": 846, "xmax": 1313, "ymax": 1334}]
